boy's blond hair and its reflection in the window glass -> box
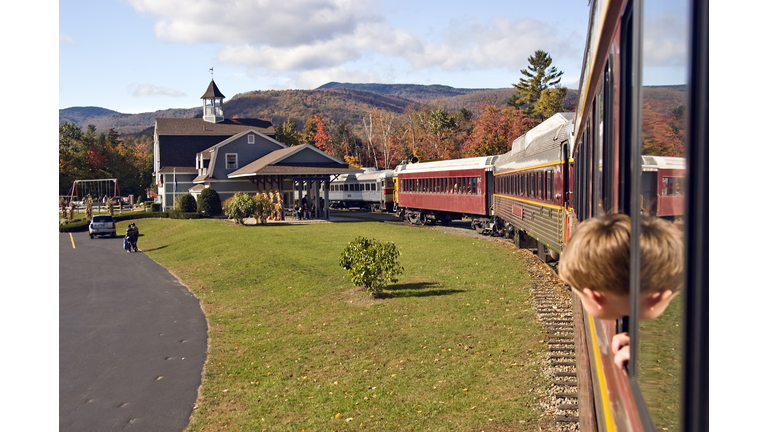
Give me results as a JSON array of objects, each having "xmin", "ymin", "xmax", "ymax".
[{"xmin": 559, "ymin": 214, "xmax": 683, "ymax": 294}]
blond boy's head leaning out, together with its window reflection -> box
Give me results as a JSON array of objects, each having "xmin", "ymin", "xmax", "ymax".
[{"xmin": 559, "ymin": 214, "xmax": 683, "ymax": 319}]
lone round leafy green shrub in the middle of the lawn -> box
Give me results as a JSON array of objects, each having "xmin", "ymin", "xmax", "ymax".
[{"xmin": 339, "ymin": 237, "xmax": 403, "ymax": 297}]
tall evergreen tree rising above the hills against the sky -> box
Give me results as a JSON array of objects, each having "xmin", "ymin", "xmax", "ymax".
[{"xmin": 507, "ymin": 50, "xmax": 563, "ymax": 115}]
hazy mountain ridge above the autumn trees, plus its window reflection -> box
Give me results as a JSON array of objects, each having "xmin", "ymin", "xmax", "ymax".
[{"xmin": 59, "ymin": 82, "xmax": 686, "ymax": 135}]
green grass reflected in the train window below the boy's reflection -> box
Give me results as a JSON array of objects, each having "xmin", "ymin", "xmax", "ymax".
[{"xmin": 638, "ymin": 294, "xmax": 683, "ymax": 432}]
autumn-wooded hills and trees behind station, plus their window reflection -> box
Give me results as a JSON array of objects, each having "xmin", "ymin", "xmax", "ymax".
[{"xmin": 60, "ymin": 83, "xmax": 685, "ymax": 186}]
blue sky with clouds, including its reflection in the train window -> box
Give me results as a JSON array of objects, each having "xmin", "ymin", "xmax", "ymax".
[{"xmin": 58, "ymin": 0, "xmax": 685, "ymax": 113}]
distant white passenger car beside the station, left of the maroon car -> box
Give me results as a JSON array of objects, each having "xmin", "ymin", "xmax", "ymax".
[{"xmin": 328, "ymin": 168, "xmax": 395, "ymax": 212}]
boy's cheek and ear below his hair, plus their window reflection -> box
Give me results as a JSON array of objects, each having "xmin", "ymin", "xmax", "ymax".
[{"xmin": 573, "ymin": 288, "xmax": 677, "ymax": 321}]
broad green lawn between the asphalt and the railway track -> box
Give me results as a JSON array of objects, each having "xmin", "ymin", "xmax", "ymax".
[{"xmin": 130, "ymin": 219, "xmax": 550, "ymax": 431}]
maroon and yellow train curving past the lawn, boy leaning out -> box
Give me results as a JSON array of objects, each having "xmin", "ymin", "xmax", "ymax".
[{"xmin": 324, "ymin": 0, "xmax": 709, "ymax": 432}]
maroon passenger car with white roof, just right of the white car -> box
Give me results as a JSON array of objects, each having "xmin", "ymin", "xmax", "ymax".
[{"xmin": 395, "ymin": 156, "xmax": 498, "ymax": 231}]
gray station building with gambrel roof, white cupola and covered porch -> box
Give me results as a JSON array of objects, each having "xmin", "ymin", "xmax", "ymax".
[{"xmin": 154, "ymin": 80, "xmax": 361, "ymax": 218}]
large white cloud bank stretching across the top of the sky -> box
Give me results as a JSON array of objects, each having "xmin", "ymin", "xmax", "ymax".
[{"xmin": 127, "ymin": 0, "xmax": 583, "ymax": 81}]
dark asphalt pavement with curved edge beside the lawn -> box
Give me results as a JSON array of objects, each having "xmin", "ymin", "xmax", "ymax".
[{"xmin": 59, "ymin": 231, "xmax": 208, "ymax": 432}]
